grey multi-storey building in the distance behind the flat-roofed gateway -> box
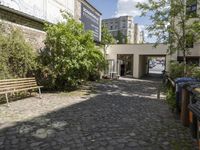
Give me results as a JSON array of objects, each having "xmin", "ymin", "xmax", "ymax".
[{"xmin": 102, "ymin": 16, "xmax": 144, "ymax": 44}]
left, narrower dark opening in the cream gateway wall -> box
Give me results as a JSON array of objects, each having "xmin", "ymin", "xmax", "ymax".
[{"xmin": 117, "ymin": 54, "xmax": 133, "ymax": 77}]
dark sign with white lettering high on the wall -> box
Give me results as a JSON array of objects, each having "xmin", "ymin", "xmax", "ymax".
[{"xmin": 80, "ymin": 3, "xmax": 101, "ymax": 42}]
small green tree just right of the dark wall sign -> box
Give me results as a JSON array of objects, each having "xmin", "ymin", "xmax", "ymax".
[{"xmin": 101, "ymin": 25, "xmax": 115, "ymax": 54}]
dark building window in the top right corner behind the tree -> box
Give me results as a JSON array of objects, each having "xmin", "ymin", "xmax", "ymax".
[{"xmin": 186, "ymin": 0, "xmax": 197, "ymax": 18}]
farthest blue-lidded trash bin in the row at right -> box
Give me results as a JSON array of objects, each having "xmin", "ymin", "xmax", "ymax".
[{"xmin": 175, "ymin": 77, "xmax": 198, "ymax": 115}]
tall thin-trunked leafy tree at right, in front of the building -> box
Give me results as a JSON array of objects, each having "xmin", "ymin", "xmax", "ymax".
[{"xmin": 137, "ymin": 0, "xmax": 200, "ymax": 76}]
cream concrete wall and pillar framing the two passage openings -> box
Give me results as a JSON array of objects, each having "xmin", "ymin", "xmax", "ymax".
[{"xmin": 106, "ymin": 44, "xmax": 170, "ymax": 78}]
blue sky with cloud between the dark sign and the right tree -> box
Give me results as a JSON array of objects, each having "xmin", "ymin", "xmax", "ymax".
[{"xmin": 88, "ymin": 0, "xmax": 154, "ymax": 43}]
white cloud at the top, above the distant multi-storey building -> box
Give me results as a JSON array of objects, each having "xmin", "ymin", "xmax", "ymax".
[{"xmin": 115, "ymin": 0, "xmax": 148, "ymax": 17}]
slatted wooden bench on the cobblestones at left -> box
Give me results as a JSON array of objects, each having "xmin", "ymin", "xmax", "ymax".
[{"xmin": 0, "ymin": 78, "xmax": 42, "ymax": 106}]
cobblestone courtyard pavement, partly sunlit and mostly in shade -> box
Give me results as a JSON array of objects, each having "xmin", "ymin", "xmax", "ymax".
[{"xmin": 0, "ymin": 80, "xmax": 198, "ymax": 150}]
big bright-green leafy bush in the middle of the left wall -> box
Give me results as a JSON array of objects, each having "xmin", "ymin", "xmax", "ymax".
[{"xmin": 39, "ymin": 15, "xmax": 105, "ymax": 90}]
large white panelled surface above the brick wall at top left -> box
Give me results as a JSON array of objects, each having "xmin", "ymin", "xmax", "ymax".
[{"xmin": 0, "ymin": 0, "xmax": 74, "ymax": 23}]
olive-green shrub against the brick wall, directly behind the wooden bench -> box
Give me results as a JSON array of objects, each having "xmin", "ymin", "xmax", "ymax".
[{"xmin": 0, "ymin": 29, "xmax": 36, "ymax": 79}]
